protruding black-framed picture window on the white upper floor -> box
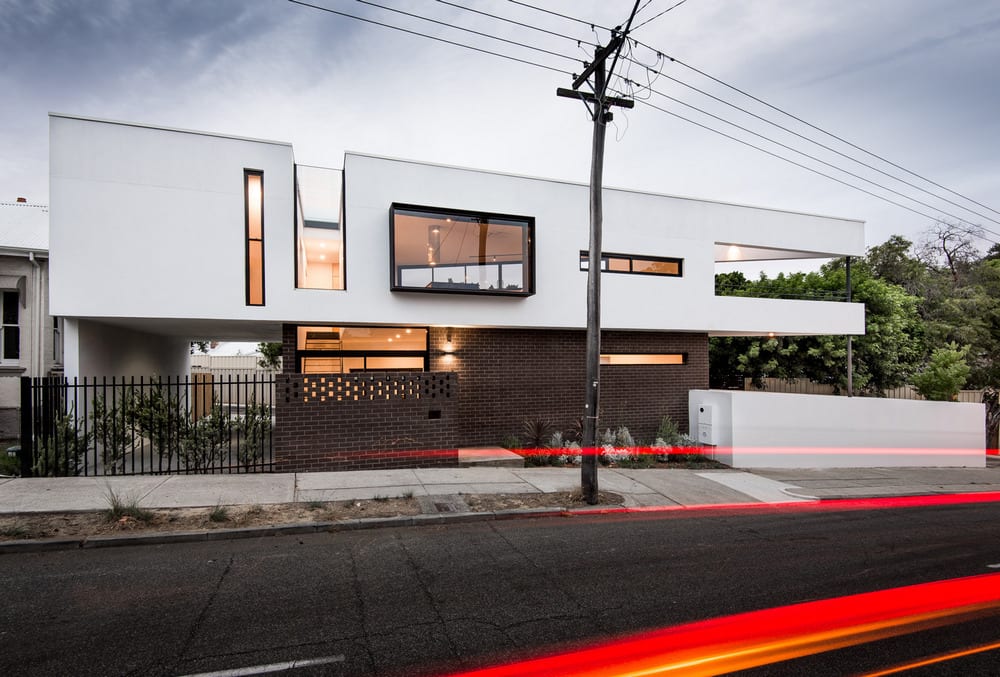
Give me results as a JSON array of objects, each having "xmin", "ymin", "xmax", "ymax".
[{"xmin": 389, "ymin": 203, "xmax": 535, "ymax": 296}]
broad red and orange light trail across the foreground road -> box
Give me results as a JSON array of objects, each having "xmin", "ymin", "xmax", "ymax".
[{"xmin": 446, "ymin": 574, "xmax": 1000, "ymax": 677}]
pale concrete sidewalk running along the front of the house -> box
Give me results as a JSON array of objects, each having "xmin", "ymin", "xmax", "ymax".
[{"xmin": 0, "ymin": 459, "xmax": 1000, "ymax": 514}]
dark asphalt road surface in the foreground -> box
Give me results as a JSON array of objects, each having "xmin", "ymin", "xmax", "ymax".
[{"xmin": 0, "ymin": 505, "xmax": 1000, "ymax": 677}]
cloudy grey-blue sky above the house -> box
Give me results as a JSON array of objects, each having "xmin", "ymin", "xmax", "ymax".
[{"xmin": 0, "ymin": 0, "xmax": 1000, "ymax": 262}]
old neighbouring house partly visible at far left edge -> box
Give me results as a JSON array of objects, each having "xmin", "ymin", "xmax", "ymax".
[{"xmin": 0, "ymin": 198, "xmax": 62, "ymax": 439}]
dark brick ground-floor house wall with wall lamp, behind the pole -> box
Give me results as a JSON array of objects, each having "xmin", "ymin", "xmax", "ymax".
[{"xmin": 430, "ymin": 327, "xmax": 708, "ymax": 445}]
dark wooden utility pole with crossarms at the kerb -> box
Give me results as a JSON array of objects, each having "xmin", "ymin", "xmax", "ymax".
[{"xmin": 556, "ymin": 5, "xmax": 639, "ymax": 505}]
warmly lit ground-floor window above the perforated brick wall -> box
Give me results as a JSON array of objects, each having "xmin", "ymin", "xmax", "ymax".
[{"xmin": 295, "ymin": 326, "xmax": 428, "ymax": 374}]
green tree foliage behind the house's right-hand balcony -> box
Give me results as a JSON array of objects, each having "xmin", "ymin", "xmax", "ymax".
[{"xmin": 710, "ymin": 222, "xmax": 1000, "ymax": 395}]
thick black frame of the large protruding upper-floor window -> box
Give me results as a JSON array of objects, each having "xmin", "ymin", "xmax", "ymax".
[{"xmin": 389, "ymin": 202, "xmax": 535, "ymax": 298}]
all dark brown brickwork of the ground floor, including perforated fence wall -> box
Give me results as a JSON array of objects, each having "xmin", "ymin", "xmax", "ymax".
[{"xmin": 274, "ymin": 325, "xmax": 708, "ymax": 471}]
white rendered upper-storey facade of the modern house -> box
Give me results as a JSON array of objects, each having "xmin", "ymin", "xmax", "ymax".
[{"xmin": 50, "ymin": 115, "xmax": 864, "ymax": 377}]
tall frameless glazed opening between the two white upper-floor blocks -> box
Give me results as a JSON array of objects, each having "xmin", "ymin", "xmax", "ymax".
[{"xmin": 295, "ymin": 165, "xmax": 344, "ymax": 289}]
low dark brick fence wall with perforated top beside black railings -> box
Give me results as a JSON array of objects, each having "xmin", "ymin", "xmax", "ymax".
[{"xmin": 274, "ymin": 373, "xmax": 459, "ymax": 472}]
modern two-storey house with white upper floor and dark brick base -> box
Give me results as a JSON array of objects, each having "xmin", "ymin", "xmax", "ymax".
[{"xmin": 50, "ymin": 114, "xmax": 864, "ymax": 470}]
